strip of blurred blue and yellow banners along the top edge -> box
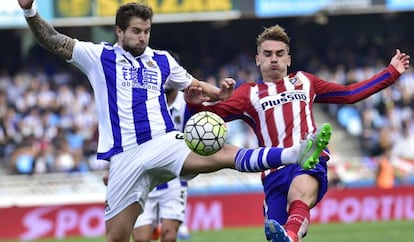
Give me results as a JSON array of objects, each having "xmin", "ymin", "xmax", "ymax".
[{"xmin": 0, "ymin": 0, "xmax": 414, "ymax": 28}]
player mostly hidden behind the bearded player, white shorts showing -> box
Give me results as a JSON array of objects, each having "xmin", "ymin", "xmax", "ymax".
[{"xmin": 132, "ymin": 89, "xmax": 191, "ymax": 242}]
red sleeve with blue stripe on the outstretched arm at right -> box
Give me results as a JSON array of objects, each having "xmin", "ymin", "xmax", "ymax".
[{"xmin": 314, "ymin": 65, "xmax": 400, "ymax": 104}]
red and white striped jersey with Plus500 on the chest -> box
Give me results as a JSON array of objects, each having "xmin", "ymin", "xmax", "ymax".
[{"xmin": 191, "ymin": 65, "xmax": 400, "ymax": 176}]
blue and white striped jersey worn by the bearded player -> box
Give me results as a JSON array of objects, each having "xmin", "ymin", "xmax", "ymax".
[{"xmin": 69, "ymin": 41, "xmax": 193, "ymax": 160}]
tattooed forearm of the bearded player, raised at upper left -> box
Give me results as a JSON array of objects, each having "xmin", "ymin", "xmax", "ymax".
[{"xmin": 26, "ymin": 14, "xmax": 76, "ymax": 60}]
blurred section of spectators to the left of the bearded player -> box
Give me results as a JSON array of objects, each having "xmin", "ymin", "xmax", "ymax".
[{"xmin": 0, "ymin": 66, "xmax": 102, "ymax": 174}]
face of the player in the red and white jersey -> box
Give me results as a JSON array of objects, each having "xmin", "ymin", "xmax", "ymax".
[{"xmin": 256, "ymin": 40, "xmax": 291, "ymax": 81}]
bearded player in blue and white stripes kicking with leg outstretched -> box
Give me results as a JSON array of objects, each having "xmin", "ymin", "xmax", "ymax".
[{"xmin": 18, "ymin": 0, "xmax": 330, "ymax": 242}]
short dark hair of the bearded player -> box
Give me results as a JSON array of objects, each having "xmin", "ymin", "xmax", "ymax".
[{"xmin": 115, "ymin": 2, "xmax": 154, "ymax": 31}]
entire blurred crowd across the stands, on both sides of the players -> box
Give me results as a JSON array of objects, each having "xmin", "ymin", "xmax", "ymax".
[{"xmin": 0, "ymin": 12, "xmax": 414, "ymax": 187}]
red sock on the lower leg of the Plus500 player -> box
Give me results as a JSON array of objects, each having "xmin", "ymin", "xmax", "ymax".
[{"xmin": 285, "ymin": 200, "xmax": 310, "ymax": 241}]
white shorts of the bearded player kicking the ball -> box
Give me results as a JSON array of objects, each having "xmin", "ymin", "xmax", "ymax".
[{"xmin": 104, "ymin": 131, "xmax": 190, "ymax": 221}]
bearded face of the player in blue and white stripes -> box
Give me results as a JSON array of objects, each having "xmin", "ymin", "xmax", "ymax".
[{"xmin": 116, "ymin": 18, "xmax": 151, "ymax": 56}]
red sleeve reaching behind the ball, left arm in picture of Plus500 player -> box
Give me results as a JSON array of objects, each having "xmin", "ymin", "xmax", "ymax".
[{"xmin": 188, "ymin": 85, "xmax": 250, "ymax": 122}]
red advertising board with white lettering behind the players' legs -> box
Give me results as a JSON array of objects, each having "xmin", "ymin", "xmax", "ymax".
[{"xmin": 0, "ymin": 186, "xmax": 414, "ymax": 240}]
